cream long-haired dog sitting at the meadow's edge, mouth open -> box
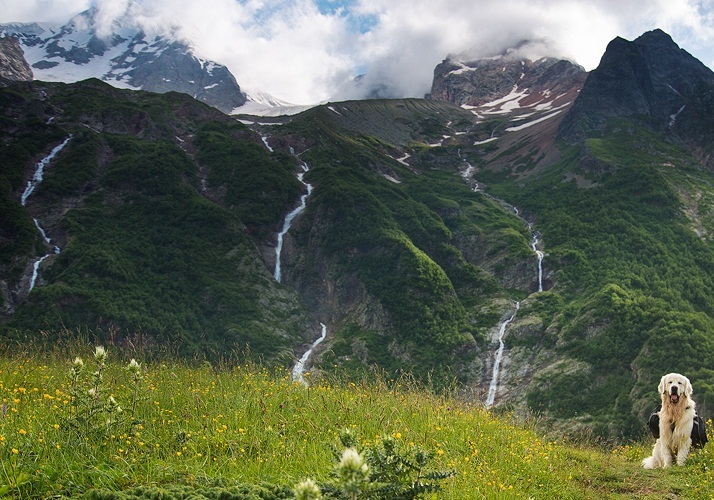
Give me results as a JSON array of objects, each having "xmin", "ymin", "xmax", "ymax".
[{"xmin": 642, "ymin": 373, "xmax": 696, "ymax": 469}]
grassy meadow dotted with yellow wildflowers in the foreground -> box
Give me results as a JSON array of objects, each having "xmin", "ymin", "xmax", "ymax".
[{"xmin": 0, "ymin": 345, "xmax": 714, "ymax": 499}]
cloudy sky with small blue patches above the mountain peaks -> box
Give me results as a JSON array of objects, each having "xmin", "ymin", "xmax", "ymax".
[{"xmin": 0, "ymin": 0, "xmax": 714, "ymax": 104}]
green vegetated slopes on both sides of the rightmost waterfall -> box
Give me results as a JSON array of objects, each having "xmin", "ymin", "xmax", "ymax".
[{"xmin": 266, "ymin": 94, "xmax": 714, "ymax": 437}]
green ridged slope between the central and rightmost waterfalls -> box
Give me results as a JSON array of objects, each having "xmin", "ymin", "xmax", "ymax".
[{"xmin": 276, "ymin": 101, "xmax": 535, "ymax": 385}]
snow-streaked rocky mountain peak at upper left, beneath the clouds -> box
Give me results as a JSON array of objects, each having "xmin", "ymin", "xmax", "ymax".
[{"xmin": 0, "ymin": 9, "xmax": 246, "ymax": 113}]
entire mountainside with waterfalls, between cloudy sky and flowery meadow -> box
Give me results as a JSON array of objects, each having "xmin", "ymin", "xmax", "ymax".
[{"xmin": 0, "ymin": 21, "xmax": 714, "ymax": 438}]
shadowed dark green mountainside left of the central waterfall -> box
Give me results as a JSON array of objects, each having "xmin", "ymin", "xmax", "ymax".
[{"xmin": 0, "ymin": 81, "xmax": 307, "ymax": 362}]
